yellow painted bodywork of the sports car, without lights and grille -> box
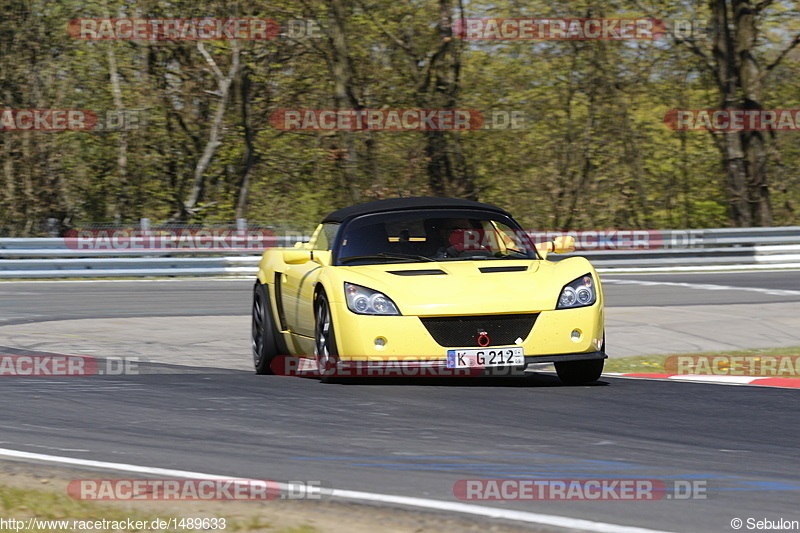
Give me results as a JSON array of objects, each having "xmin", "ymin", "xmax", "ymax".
[{"xmin": 258, "ymin": 240, "xmax": 604, "ymax": 361}]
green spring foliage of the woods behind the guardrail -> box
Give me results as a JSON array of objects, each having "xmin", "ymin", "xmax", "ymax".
[{"xmin": 0, "ymin": 0, "xmax": 800, "ymax": 229}]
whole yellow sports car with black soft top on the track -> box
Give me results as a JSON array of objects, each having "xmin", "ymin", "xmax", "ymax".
[{"xmin": 252, "ymin": 198, "xmax": 607, "ymax": 384}]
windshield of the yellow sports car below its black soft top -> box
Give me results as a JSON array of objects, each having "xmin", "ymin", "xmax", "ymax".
[{"xmin": 337, "ymin": 210, "xmax": 537, "ymax": 265}]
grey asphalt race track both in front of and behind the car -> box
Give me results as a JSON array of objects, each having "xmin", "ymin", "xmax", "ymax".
[{"xmin": 0, "ymin": 272, "xmax": 800, "ymax": 532}]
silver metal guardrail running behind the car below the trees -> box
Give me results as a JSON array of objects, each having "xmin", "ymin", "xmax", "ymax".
[{"xmin": 0, "ymin": 226, "xmax": 800, "ymax": 279}]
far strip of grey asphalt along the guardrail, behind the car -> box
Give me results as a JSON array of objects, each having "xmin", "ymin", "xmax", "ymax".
[{"xmin": 0, "ymin": 271, "xmax": 800, "ymax": 324}]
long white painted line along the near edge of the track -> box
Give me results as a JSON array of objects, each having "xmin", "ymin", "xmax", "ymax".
[{"xmin": 0, "ymin": 448, "xmax": 668, "ymax": 533}]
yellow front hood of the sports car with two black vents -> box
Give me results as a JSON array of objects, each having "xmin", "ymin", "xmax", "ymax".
[{"xmin": 340, "ymin": 260, "xmax": 580, "ymax": 316}]
